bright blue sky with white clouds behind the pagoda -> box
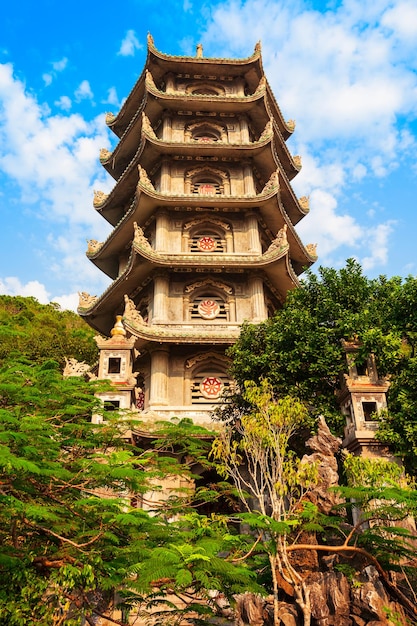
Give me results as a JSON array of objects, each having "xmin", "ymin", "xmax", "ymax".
[{"xmin": 0, "ymin": 0, "xmax": 417, "ymax": 308}]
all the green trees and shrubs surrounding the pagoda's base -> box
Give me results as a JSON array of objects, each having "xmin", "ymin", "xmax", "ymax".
[{"xmin": 0, "ymin": 270, "xmax": 417, "ymax": 626}]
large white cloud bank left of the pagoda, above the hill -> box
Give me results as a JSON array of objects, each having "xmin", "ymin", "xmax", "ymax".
[{"xmin": 0, "ymin": 64, "xmax": 114, "ymax": 298}]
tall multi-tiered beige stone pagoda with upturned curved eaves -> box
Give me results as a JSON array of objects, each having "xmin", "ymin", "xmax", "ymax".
[{"xmin": 79, "ymin": 36, "xmax": 316, "ymax": 423}]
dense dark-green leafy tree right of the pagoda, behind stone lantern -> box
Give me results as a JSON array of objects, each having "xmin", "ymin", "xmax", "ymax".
[{"xmin": 230, "ymin": 260, "xmax": 417, "ymax": 472}]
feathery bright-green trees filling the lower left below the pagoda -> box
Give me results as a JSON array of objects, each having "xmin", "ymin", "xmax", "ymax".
[{"xmin": 0, "ymin": 359, "xmax": 259, "ymax": 626}]
